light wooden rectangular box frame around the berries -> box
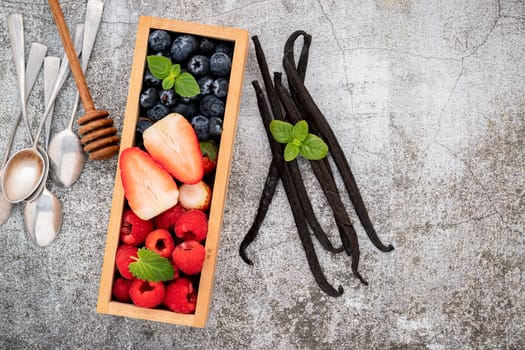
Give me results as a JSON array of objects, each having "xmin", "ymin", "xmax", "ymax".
[{"xmin": 97, "ymin": 16, "xmax": 249, "ymax": 327}]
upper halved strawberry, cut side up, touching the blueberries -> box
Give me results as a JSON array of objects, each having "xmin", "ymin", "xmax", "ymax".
[{"xmin": 143, "ymin": 113, "xmax": 204, "ymax": 184}]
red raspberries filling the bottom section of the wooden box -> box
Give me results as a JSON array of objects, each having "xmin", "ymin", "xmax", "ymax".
[{"xmin": 112, "ymin": 204, "xmax": 208, "ymax": 314}]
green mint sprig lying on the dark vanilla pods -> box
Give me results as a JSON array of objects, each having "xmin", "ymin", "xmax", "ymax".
[{"xmin": 270, "ymin": 120, "xmax": 328, "ymax": 162}]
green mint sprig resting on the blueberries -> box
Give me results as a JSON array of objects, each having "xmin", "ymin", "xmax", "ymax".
[{"xmin": 146, "ymin": 55, "xmax": 201, "ymax": 97}]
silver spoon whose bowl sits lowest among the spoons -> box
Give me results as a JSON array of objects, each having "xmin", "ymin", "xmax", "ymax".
[{"xmin": 24, "ymin": 56, "xmax": 62, "ymax": 247}]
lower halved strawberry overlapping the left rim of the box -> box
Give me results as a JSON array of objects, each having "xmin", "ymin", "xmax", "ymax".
[{"xmin": 119, "ymin": 147, "xmax": 179, "ymax": 220}]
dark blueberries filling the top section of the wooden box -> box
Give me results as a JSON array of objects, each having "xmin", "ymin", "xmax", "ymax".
[{"xmin": 137, "ymin": 30, "xmax": 233, "ymax": 141}]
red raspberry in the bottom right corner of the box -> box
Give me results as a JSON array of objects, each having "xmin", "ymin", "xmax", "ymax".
[{"xmin": 162, "ymin": 277, "xmax": 197, "ymax": 314}]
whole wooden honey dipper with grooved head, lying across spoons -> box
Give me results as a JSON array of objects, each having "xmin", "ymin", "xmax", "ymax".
[{"xmin": 48, "ymin": 0, "xmax": 120, "ymax": 160}]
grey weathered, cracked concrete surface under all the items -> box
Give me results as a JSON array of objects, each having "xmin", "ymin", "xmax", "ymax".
[{"xmin": 0, "ymin": 0, "xmax": 525, "ymax": 349}]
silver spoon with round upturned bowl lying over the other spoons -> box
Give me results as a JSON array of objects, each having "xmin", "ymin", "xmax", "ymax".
[{"xmin": 2, "ymin": 24, "xmax": 84, "ymax": 203}]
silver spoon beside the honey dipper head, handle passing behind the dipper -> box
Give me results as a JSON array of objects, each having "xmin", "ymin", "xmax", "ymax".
[{"xmin": 48, "ymin": 0, "xmax": 104, "ymax": 187}]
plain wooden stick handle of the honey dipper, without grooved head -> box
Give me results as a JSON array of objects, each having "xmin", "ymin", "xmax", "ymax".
[{"xmin": 48, "ymin": 0, "xmax": 95, "ymax": 113}]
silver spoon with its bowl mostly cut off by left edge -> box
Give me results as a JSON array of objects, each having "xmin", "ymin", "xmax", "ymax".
[{"xmin": 0, "ymin": 43, "xmax": 47, "ymax": 225}]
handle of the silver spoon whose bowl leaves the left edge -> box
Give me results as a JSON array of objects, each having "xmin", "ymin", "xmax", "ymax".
[{"xmin": 2, "ymin": 43, "xmax": 47, "ymax": 168}]
